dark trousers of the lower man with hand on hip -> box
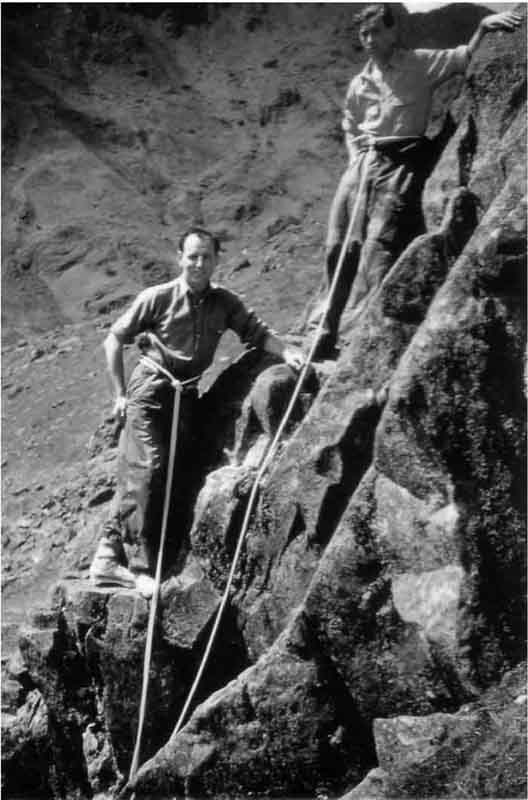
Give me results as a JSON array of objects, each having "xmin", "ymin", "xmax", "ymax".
[{"xmin": 105, "ymin": 364, "xmax": 198, "ymax": 574}]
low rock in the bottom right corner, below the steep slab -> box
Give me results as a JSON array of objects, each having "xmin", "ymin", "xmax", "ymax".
[{"xmin": 342, "ymin": 665, "xmax": 526, "ymax": 800}]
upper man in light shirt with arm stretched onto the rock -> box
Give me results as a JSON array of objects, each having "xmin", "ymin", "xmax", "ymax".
[{"xmin": 308, "ymin": 3, "xmax": 521, "ymax": 358}]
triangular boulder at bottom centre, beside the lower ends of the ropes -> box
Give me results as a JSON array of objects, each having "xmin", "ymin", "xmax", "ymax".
[{"xmin": 134, "ymin": 630, "xmax": 374, "ymax": 796}]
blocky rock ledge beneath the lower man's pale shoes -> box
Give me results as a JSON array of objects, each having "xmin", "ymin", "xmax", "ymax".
[{"xmin": 2, "ymin": 576, "xmax": 251, "ymax": 797}]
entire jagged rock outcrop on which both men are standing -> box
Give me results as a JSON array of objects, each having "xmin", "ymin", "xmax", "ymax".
[{"xmin": 5, "ymin": 4, "xmax": 526, "ymax": 800}]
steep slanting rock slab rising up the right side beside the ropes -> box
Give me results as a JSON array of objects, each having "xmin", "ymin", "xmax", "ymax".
[{"xmin": 131, "ymin": 9, "xmax": 526, "ymax": 794}]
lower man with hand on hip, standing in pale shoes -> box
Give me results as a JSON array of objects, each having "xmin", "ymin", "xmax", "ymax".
[{"xmin": 90, "ymin": 227, "xmax": 303, "ymax": 597}]
